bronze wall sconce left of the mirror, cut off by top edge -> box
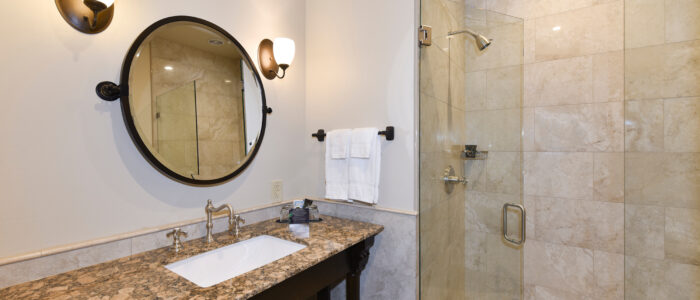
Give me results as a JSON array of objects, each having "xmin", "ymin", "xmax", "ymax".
[{"xmin": 56, "ymin": 0, "xmax": 114, "ymax": 34}]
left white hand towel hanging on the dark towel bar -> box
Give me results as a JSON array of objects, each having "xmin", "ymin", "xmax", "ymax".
[{"xmin": 326, "ymin": 129, "xmax": 351, "ymax": 200}]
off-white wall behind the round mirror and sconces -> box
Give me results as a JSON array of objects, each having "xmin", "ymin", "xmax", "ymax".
[{"xmin": 0, "ymin": 0, "xmax": 308, "ymax": 257}]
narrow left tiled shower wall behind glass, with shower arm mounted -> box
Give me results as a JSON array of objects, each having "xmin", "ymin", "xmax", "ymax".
[{"xmin": 420, "ymin": 0, "xmax": 466, "ymax": 299}]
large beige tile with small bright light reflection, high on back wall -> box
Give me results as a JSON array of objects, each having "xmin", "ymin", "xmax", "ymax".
[{"xmin": 535, "ymin": 1, "xmax": 624, "ymax": 61}]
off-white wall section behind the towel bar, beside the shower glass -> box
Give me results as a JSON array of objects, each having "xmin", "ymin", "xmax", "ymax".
[{"xmin": 305, "ymin": 0, "xmax": 418, "ymax": 211}]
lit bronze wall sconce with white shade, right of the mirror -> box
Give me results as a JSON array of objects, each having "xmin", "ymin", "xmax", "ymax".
[{"xmin": 258, "ymin": 38, "xmax": 294, "ymax": 80}]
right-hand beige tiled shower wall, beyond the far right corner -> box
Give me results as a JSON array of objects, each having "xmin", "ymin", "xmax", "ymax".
[{"xmin": 625, "ymin": 0, "xmax": 700, "ymax": 299}]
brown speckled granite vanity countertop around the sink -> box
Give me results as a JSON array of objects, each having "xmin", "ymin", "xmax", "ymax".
[{"xmin": 0, "ymin": 216, "xmax": 384, "ymax": 299}]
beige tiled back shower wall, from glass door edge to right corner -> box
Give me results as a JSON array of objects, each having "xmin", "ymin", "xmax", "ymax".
[{"xmin": 484, "ymin": 0, "xmax": 625, "ymax": 299}]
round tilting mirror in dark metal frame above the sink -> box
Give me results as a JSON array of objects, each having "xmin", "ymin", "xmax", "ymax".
[{"xmin": 120, "ymin": 16, "xmax": 267, "ymax": 185}]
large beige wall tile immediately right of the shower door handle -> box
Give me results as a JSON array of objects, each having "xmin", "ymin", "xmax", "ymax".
[{"xmin": 535, "ymin": 197, "xmax": 624, "ymax": 253}]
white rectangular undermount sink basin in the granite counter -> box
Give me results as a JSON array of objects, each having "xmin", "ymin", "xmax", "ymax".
[{"xmin": 165, "ymin": 235, "xmax": 306, "ymax": 287}]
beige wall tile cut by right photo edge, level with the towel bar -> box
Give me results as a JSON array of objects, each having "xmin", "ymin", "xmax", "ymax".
[{"xmin": 664, "ymin": 97, "xmax": 700, "ymax": 152}]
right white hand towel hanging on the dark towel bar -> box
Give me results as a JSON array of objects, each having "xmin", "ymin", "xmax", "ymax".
[{"xmin": 348, "ymin": 128, "xmax": 381, "ymax": 204}]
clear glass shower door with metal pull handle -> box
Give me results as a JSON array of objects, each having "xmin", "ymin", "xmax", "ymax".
[{"xmin": 419, "ymin": 0, "xmax": 527, "ymax": 299}]
